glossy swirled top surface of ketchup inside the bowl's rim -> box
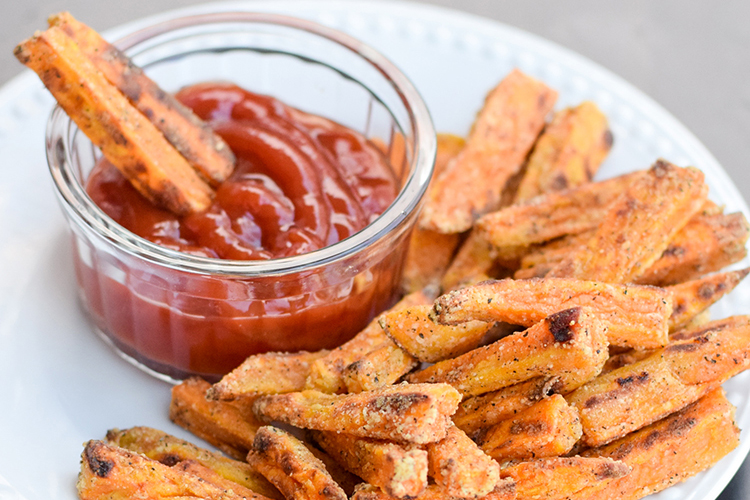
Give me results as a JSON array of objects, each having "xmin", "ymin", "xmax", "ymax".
[{"xmin": 87, "ymin": 83, "xmax": 398, "ymax": 260}]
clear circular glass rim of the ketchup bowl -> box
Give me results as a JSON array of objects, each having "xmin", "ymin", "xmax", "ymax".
[{"xmin": 46, "ymin": 11, "xmax": 437, "ymax": 277}]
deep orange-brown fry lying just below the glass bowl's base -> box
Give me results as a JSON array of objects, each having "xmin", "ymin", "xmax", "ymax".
[{"xmin": 169, "ymin": 378, "xmax": 261, "ymax": 460}]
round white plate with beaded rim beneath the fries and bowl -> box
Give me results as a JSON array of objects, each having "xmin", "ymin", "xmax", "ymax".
[{"xmin": 0, "ymin": 1, "xmax": 750, "ymax": 500}]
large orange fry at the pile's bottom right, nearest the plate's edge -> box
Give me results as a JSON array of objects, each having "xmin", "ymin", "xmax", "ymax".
[{"xmin": 574, "ymin": 389, "xmax": 739, "ymax": 500}]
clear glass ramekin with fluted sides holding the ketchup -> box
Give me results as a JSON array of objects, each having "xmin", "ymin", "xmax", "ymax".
[{"xmin": 46, "ymin": 12, "xmax": 436, "ymax": 381}]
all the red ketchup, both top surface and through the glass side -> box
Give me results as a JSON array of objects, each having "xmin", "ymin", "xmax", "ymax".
[{"xmin": 77, "ymin": 83, "xmax": 405, "ymax": 379}]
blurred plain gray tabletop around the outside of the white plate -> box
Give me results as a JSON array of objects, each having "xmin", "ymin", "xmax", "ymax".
[{"xmin": 0, "ymin": 0, "xmax": 750, "ymax": 500}]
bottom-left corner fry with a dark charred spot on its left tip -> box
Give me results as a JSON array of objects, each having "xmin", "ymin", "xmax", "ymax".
[{"xmin": 76, "ymin": 441, "xmax": 265, "ymax": 500}]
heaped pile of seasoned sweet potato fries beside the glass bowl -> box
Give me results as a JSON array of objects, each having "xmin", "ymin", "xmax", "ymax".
[{"xmin": 16, "ymin": 12, "xmax": 750, "ymax": 500}]
